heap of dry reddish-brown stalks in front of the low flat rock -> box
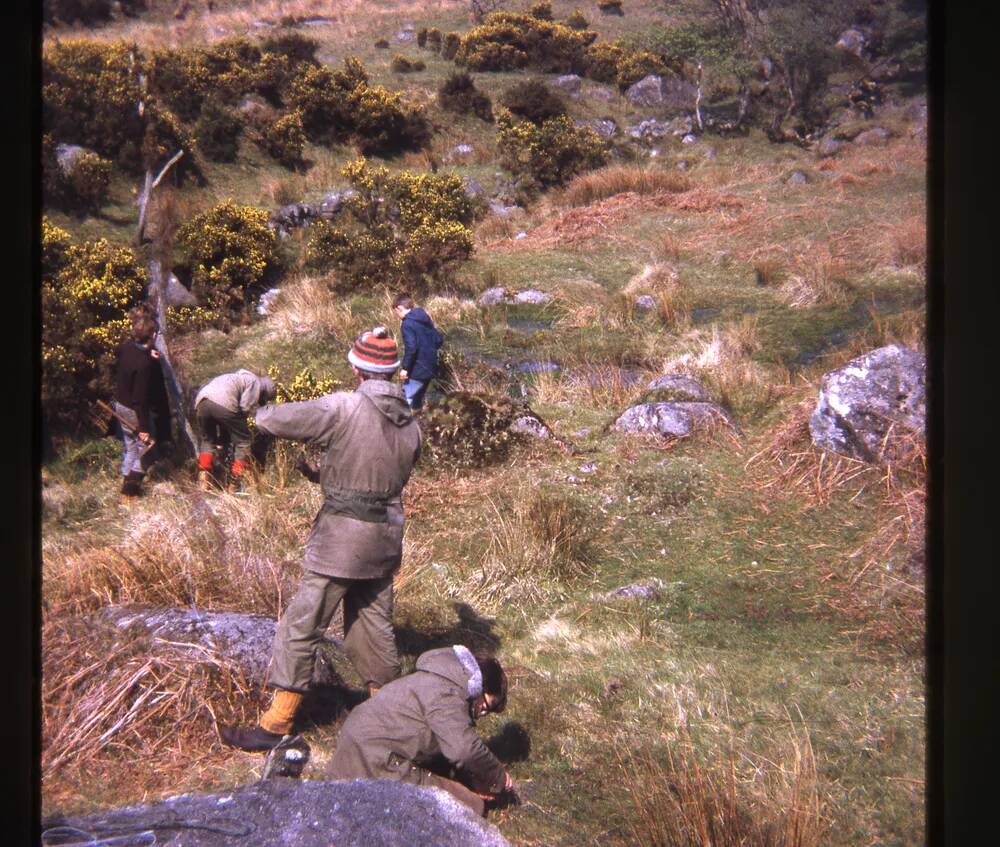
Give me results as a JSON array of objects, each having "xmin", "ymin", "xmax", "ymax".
[{"xmin": 41, "ymin": 614, "xmax": 257, "ymax": 788}]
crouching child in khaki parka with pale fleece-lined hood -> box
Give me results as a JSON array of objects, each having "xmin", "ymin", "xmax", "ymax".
[{"xmin": 327, "ymin": 644, "xmax": 514, "ymax": 815}]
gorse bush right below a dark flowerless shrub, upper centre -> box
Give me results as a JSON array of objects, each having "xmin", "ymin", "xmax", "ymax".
[{"xmin": 497, "ymin": 109, "xmax": 608, "ymax": 187}]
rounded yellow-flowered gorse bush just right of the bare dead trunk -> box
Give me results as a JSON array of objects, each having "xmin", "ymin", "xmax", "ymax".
[{"xmin": 177, "ymin": 200, "xmax": 279, "ymax": 314}]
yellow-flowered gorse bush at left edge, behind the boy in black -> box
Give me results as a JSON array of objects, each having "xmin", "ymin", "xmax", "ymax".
[{"xmin": 41, "ymin": 218, "xmax": 146, "ymax": 428}]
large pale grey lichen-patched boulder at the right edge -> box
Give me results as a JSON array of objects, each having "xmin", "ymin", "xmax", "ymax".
[{"xmin": 809, "ymin": 344, "xmax": 927, "ymax": 462}]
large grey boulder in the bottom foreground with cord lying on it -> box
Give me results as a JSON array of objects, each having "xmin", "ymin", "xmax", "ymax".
[{"xmin": 42, "ymin": 779, "xmax": 509, "ymax": 847}]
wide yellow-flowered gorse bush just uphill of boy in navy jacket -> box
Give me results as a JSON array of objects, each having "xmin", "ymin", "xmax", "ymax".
[{"xmin": 306, "ymin": 159, "xmax": 479, "ymax": 291}]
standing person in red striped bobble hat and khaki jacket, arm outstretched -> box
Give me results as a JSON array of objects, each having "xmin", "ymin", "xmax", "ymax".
[{"xmin": 219, "ymin": 327, "xmax": 421, "ymax": 751}]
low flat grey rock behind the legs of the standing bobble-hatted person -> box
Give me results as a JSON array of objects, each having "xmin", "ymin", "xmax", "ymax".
[{"xmin": 98, "ymin": 605, "xmax": 341, "ymax": 685}]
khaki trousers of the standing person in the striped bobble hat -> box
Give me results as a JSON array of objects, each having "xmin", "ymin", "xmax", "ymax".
[{"xmin": 267, "ymin": 570, "xmax": 400, "ymax": 691}]
